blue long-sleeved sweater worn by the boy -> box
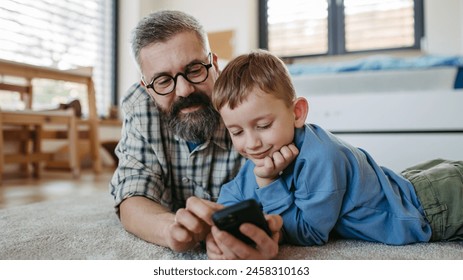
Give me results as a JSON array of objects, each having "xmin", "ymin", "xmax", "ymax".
[{"xmin": 218, "ymin": 124, "xmax": 431, "ymax": 245}]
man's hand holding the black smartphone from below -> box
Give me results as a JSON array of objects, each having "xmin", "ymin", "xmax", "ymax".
[{"xmin": 206, "ymin": 215, "xmax": 283, "ymax": 260}]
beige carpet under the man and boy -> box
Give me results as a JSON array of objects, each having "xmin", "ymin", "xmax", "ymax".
[{"xmin": 0, "ymin": 192, "xmax": 463, "ymax": 260}]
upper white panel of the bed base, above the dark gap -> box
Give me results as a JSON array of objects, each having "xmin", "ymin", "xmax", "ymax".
[{"xmin": 301, "ymin": 90, "xmax": 463, "ymax": 131}]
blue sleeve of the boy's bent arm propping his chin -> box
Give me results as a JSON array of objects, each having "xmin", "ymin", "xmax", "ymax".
[{"xmin": 256, "ymin": 149, "xmax": 348, "ymax": 246}]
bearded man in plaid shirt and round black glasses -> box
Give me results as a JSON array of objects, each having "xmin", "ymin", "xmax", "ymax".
[{"xmin": 110, "ymin": 11, "xmax": 282, "ymax": 259}]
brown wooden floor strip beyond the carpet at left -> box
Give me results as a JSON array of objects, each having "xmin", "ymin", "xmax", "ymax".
[{"xmin": 0, "ymin": 169, "xmax": 113, "ymax": 209}]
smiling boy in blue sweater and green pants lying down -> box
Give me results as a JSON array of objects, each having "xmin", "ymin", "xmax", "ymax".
[{"xmin": 212, "ymin": 51, "xmax": 463, "ymax": 245}]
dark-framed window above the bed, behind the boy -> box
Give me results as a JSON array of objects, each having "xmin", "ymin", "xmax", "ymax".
[{"xmin": 259, "ymin": 0, "xmax": 423, "ymax": 57}]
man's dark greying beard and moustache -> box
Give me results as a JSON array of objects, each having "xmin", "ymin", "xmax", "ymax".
[{"xmin": 159, "ymin": 92, "xmax": 220, "ymax": 143}]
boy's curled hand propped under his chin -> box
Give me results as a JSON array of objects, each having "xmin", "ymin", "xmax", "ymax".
[{"xmin": 254, "ymin": 144, "xmax": 299, "ymax": 187}]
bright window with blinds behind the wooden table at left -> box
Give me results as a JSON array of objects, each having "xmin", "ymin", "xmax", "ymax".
[{"xmin": 0, "ymin": 0, "xmax": 117, "ymax": 116}]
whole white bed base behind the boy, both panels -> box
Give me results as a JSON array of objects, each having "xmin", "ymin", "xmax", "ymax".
[{"xmin": 293, "ymin": 69, "xmax": 463, "ymax": 171}]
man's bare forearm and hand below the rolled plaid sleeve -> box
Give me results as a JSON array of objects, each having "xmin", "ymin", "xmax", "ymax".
[{"xmin": 119, "ymin": 196, "xmax": 205, "ymax": 252}]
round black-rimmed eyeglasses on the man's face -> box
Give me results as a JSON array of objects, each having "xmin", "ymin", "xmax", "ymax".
[{"xmin": 142, "ymin": 53, "xmax": 212, "ymax": 95}]
